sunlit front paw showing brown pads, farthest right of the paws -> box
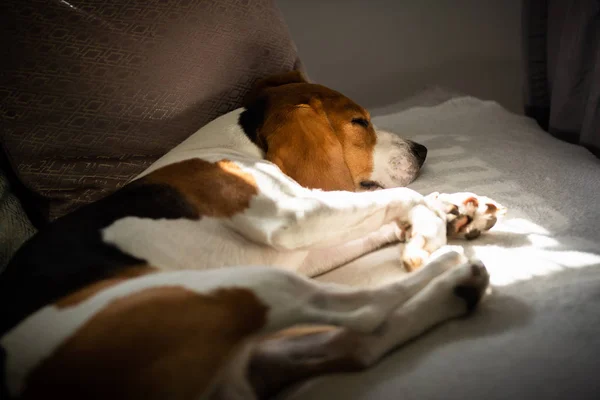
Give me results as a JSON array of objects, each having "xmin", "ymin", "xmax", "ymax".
[{"xmin": 426, "ymin": 192, "xmax": 506, "ymax": 240}]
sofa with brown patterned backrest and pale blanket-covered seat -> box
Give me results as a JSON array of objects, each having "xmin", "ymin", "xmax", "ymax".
[{"xmin": 0, "ymin": 0, "xmax": 600, "ymax": 400}]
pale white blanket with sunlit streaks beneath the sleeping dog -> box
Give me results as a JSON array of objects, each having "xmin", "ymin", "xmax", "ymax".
[{"xmin": 285, "ymin": 93, "xmax": 600, "ymax": 400}]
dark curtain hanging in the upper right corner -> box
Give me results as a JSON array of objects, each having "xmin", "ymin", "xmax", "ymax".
[{"xmin": 523, "ymin": 0, "xmax": 600, "ymax": 157}]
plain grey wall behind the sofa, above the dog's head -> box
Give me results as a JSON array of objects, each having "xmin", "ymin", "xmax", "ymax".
[{"xmin": 277, "ymin": 0, "xmax": 522, "ymax": 112}]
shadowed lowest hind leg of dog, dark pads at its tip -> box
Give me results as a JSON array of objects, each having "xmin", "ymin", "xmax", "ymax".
[{"xmin": 249, "ymin": 255, "xmax": 489, "ymax": 398}]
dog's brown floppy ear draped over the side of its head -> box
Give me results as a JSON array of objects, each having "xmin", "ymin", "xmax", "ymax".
[{"xmin": 258, "ymin": 99, "xmax": 356, "ymax": 191}]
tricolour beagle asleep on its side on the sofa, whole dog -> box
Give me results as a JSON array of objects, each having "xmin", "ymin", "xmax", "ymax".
[{"xmin": 0, "ymin": 72, "xmax": 504, "ymax": 400}]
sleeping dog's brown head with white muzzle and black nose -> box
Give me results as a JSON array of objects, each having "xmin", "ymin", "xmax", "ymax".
[{"xmin": 240, "ymin": 71, "xmax": 427, "ymax": 191}]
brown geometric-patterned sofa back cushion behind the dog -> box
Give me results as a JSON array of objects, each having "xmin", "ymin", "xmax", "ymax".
[{"xmin": 0, "ymin": 0, "xmax": 299, "ymax": 220}]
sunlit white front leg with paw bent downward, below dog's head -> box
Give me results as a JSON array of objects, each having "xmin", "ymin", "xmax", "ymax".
[{"xmin": 225, "ymin": 165, "xmax": 501, "ymax": 269}]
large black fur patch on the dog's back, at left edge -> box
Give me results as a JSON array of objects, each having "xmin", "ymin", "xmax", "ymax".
[{"xmin": 0, "ymin": 179, "xmax": 199, "ymax": 336}]
